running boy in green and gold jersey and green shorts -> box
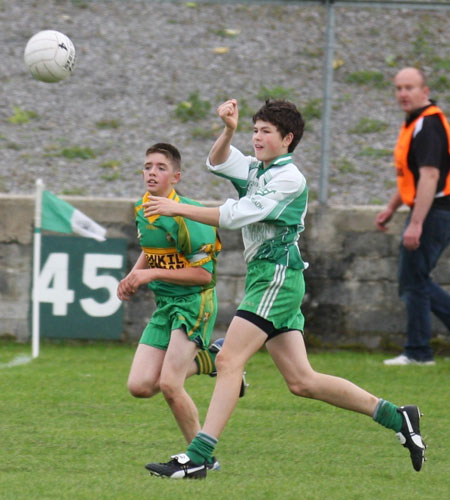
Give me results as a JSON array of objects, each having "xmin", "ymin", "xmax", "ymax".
[{"xmin": 117, "ymin": 143, "xmax": 221, "ymax": 458}]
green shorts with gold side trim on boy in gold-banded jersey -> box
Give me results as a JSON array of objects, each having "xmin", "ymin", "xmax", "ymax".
[{"xmin": 139, "ymin": 288, "xmax": 217, "ymax": 351}]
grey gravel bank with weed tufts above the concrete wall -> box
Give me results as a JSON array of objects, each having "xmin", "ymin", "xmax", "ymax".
[{"xmin": 0, "ymin": 0, "xmax": 450, "ymax": 205}]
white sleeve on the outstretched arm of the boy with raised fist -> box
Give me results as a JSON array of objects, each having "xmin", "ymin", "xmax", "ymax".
[{"xmin": 219, "ymin": 166, "xmax": 306, "ymax": 229}]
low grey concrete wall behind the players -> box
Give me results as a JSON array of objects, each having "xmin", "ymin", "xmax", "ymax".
[{"xmin": 0, "ymin": 195, "xmax": 450, "ymax": 348}]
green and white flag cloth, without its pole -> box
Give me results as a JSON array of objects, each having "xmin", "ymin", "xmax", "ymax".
[{"xmin": 41, "ymin": 190, "xmax": 106, "ymax": 241}]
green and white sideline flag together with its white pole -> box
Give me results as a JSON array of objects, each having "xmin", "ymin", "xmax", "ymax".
[{"xmin": 31, "ymin": 179, "xmax": 106, "ymax": 358}]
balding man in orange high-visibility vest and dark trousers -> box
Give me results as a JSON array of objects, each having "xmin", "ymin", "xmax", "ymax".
[{"xmin": 376, "ymin": 68, "xmax": 450, "ymax": 365}]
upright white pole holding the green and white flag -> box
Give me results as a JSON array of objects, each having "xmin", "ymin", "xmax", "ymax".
[{"xmin": 31, "ymin": 179, "xmax": 44, "ymax": 358}]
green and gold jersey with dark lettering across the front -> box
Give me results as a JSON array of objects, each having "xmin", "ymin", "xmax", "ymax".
[{"xmin": 134, "ymin": 190, "xmax": 222, "ymax": 296}]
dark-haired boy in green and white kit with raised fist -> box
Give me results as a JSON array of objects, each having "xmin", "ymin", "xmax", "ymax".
[{"xmin": 144, "ymin": 99, "xmax": 425, "ymax": 478}]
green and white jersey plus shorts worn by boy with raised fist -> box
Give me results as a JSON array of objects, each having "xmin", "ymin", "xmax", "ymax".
[{"xmin": 207, "ymin": 146, "xmax": 308, "ymax": 331}]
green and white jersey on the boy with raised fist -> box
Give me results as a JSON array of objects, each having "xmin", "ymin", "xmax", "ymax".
[{"xmin": 207, "ymin": 146, "xmax": 308, "ymax": 269}]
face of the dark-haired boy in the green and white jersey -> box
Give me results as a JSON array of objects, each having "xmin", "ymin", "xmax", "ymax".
[{"xmin": 252, "ymin": 120, "xmax": 293, "ymax": 167}]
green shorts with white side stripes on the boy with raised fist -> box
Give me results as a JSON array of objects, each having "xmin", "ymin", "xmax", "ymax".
[{"xmin": 238, "ymin": 260, "xmax": 305, "ymax": 331}]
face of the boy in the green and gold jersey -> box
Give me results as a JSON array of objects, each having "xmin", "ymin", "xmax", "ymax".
[{"xmin": 142, "ymin": 153, "xmax": 181, "ymax": 197}]
